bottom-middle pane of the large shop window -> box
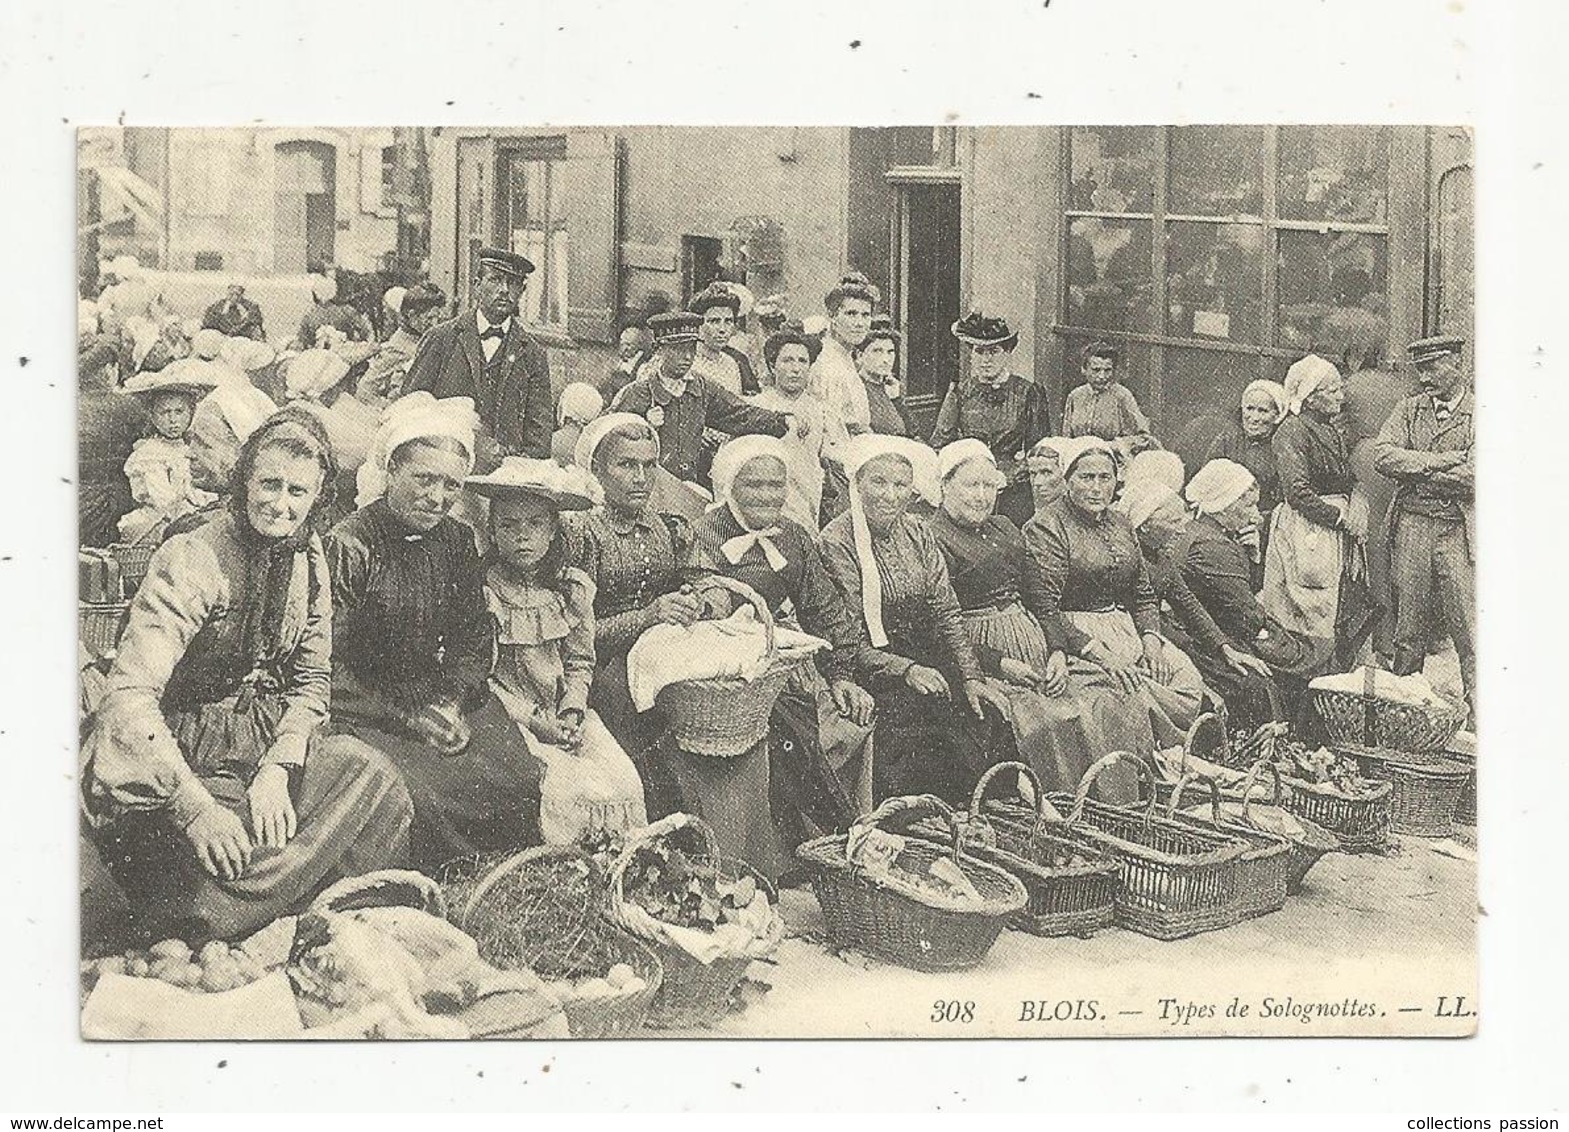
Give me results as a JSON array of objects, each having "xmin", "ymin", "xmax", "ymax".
[{"xmin": 1166, "ymin": 221, "xmax": 1265, "ymax": 342}]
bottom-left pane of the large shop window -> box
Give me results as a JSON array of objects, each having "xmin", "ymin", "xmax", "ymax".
[{"xmin": 1067, "ymin": 217, "xmax": 1155, "ymax": 333}]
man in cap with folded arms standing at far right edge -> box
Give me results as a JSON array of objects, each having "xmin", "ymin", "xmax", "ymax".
[{"xmin": 1373, "ymin": 336, "xmax": 1476, "ymax": 721}]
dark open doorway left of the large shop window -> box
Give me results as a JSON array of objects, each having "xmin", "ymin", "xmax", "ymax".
[{"xmin": 893, "ymin": 181, "xmax": 960, "ymax": 429}]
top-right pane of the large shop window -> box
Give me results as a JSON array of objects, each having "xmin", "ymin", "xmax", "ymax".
[{"xmin": 1279, "ymin": 126, "xmax": 1389, "ymax": 225}]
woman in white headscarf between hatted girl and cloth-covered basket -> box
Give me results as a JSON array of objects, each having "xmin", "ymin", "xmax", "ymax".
[{"xmin": 566, "ymin": 413, "xmax": 700, "ymax": 818}]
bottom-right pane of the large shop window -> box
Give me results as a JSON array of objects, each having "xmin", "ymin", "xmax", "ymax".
[{"xmin": 1276, "ymin": 232, "xmax": 1389, "ymax": 350}]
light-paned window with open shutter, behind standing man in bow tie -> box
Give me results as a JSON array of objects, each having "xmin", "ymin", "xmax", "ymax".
[{"xmin": 496, "ymin": 138, "xmax": 568, "ymax": 330}]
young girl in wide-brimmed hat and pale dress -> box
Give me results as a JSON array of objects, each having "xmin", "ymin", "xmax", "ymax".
[{"xmin": 468, "ymin": 457, "xmax": 648, "ymax": 845}]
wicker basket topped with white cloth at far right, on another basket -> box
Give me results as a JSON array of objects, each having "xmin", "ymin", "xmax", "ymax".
[{"xmin": 1309, "ymin": 666, "xmax": 1465, "ymax": 752}]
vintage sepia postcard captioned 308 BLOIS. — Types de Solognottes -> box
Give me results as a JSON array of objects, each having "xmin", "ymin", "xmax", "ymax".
[{"xmin": 77, "ymin": 122, "xmax": 1481, "ymax": 1039}]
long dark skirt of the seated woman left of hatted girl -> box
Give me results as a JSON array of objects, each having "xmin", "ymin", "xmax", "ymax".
[{"xmin": 333, "ymin": 692, "xmax": 543, "ymax": 871}]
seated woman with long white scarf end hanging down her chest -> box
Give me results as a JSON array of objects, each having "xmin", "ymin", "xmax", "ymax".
[{"xmin": 822, "ymin": 433, "xmax": 1007, "ymax": 802}]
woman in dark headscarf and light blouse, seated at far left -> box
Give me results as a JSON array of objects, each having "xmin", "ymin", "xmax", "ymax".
[{"xmin": 82, "ymin": 410, "xmax": 410, "ymax": 939}]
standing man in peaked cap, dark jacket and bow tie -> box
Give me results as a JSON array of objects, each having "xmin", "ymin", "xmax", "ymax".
[{"xmin": 403, "ymin": 248, "xmax": 555, "ymax": 469}]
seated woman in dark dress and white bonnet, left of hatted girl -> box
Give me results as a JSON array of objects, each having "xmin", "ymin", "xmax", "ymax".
[{"xmin": 326, "ymin": 393, "xmax": 540, "ymax": 870}]
